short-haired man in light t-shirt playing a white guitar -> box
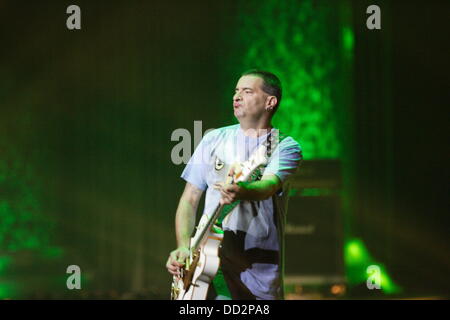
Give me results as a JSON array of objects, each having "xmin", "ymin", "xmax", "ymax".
[{"xmin": 166, "ymin": 70, "xmax": 302, "ymax": 299}]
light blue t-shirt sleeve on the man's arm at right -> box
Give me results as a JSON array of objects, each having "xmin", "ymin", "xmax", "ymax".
[{"xmin": 264, "ymin": 137, "xmax": 303, "ymax": 182}]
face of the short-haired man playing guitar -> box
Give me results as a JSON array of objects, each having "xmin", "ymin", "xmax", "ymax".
[{"xmin": 233, "ymin": 75, "xmax": 269, "ymax": 120}]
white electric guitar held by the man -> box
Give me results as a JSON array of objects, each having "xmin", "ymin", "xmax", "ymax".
[{"xmin": 171, "ymin": 144, "xmax": 268, "ymax": 300}]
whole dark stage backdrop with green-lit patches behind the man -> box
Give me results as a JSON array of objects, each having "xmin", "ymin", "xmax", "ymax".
[{"xmin": 0, "ymin": 0, "xmax": 450, "ymax": 299}]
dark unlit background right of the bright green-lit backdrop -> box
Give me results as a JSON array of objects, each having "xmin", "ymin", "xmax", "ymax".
[{"xmin": 354, "ymin": 1, "xmax": 450, "ymax": 295}]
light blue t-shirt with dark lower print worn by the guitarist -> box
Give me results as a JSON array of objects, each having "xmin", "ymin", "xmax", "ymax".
[{"xmin": 181, "ymin": 124, "xmax": 302, "ymax": 299}]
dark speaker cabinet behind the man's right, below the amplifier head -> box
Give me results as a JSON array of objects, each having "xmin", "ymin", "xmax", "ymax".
[{"xmin": 285, "ymin": 195, "xmax": 344, "ymax": 279}]
